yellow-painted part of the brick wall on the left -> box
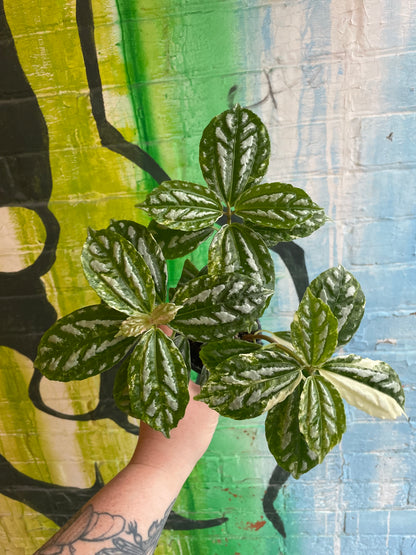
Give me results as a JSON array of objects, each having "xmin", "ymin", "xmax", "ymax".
[{"xmin": 0, "ymin": 0, "xmax": 142, "ymax": 554}]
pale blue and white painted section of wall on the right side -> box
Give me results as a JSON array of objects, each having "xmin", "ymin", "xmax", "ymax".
[{"xmin": 254, "ymin": 0, "xmax": 416, "ymax": 555}]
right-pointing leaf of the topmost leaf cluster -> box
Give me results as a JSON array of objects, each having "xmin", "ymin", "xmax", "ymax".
[{"xmin": 234, "ymin": 183, "xmax": 322, "ymax": 229}]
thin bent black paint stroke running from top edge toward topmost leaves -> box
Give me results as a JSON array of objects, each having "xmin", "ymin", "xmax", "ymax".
[{"xmin": 76, "ymin": 0, "xmax": 170, "ymax": 183}]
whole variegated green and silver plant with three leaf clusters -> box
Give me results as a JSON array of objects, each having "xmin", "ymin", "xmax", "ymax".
[{"xmin": 35, "ymin": 105, "xmax": 404, "ymax": 477}]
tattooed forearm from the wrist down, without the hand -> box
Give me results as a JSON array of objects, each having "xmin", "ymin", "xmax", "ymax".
[{"xmin": 33, "ymin": 463, "xmax": 183, "ymax": 555}]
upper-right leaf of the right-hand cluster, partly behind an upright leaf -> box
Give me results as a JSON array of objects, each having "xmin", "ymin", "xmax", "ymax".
[{"xmin": 309, "ymin": 266, "xmax": 365, "ymax": 345}]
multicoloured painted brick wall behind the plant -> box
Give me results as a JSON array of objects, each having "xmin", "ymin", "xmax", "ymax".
[{"xmin": 0, "ymin": 0, "xmax": 416, "ymax": 555}]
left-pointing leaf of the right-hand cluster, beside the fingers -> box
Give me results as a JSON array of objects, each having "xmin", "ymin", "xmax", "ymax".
[{"xmin": 198, "ymin": 348, "xmax": 302, "ymax": 420}]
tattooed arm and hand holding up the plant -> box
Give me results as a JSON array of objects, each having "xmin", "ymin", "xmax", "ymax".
[{"xmin": 36, "ymin": 384, "xmax": 217, "ymax": 555}]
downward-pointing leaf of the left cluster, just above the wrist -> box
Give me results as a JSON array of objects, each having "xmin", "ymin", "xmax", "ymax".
[{"xmin": 128, "ymin": 328, "xmax": 189, "ymax": 437}]
